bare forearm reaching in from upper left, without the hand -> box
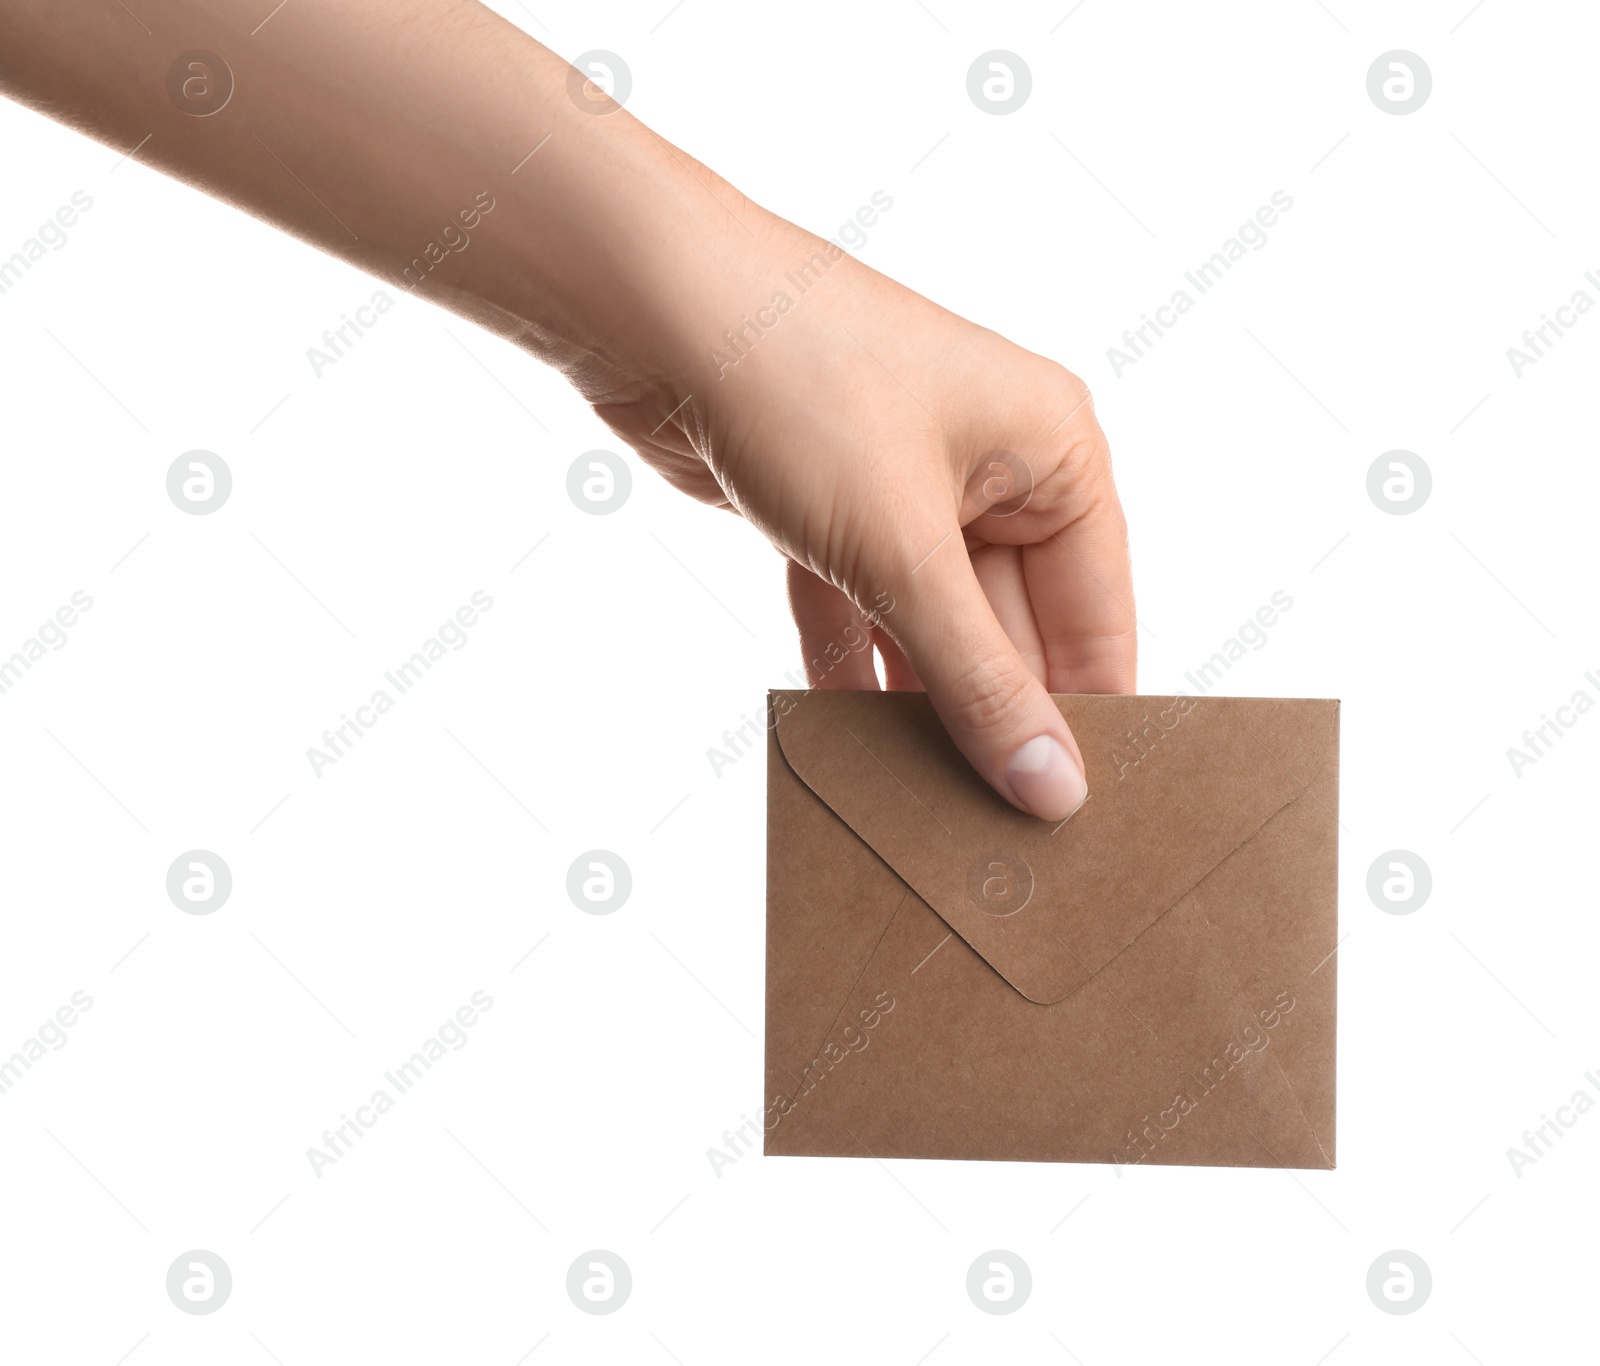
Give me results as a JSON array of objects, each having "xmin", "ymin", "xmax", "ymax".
[{"xmin": 0, "ymin": 0, "xmax": 770, "ymax": 398}]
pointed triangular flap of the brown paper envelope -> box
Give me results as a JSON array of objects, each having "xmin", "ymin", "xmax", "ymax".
[{"xmin": 770, "ymin": 691, "xmax": 1339, "ymax": 1005}]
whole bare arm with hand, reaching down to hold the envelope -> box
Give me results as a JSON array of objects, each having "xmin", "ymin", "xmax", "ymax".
[{"xmin": 0, "ymin": 0, "xmax": 1136, "ymax": 821}]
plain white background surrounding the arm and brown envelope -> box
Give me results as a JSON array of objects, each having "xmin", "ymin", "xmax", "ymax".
[{"xmin": 0, "ymin": 0, "xmax": 1600, "ymax": 1366}]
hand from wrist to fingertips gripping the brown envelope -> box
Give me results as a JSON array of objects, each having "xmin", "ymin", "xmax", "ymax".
[{"xmin": 582, "ymin": 211, "xmax": 1136, "ymax": 821}]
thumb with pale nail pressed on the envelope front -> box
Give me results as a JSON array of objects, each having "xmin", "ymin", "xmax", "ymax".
[{"xmin": 883, "ymin": 529, "xmax": 1088, "ymax": 821}]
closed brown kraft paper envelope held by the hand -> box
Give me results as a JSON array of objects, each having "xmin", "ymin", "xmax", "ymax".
[{"xmin": 763, "ymin": 691, "xmax": 1339, "ymax": 1168}]
